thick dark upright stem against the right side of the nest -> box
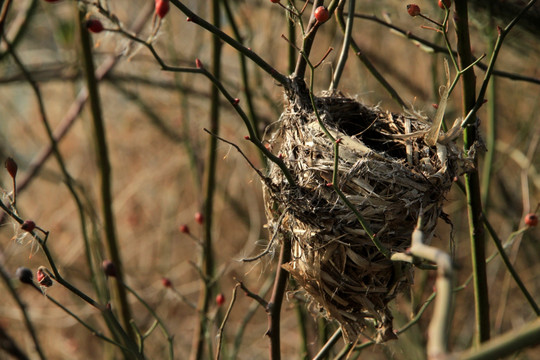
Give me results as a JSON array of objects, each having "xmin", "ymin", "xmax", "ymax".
[{"xmin": 455, "ymin": 0, "xmax": 490, "ymax": 344}]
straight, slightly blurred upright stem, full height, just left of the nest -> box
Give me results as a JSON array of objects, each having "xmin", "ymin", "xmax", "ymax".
[{"xmin": 191, "ymin": 0, "xmax": 221, "ymax": 360}]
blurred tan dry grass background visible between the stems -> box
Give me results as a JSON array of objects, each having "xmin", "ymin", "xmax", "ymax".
[{"xmin": 0, "ymin": 0, "xmax": 540, "ymax": 359}]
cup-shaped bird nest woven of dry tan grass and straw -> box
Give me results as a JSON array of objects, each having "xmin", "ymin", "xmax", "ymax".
[{"xmin": 264, "ymin": 88, "xmax": 457, "ymax": 342}]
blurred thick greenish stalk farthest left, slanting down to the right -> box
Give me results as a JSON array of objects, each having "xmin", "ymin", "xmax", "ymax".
[{"xmin": 78, "ymin": 4, "xmax": 135, "ymax": 339}]
